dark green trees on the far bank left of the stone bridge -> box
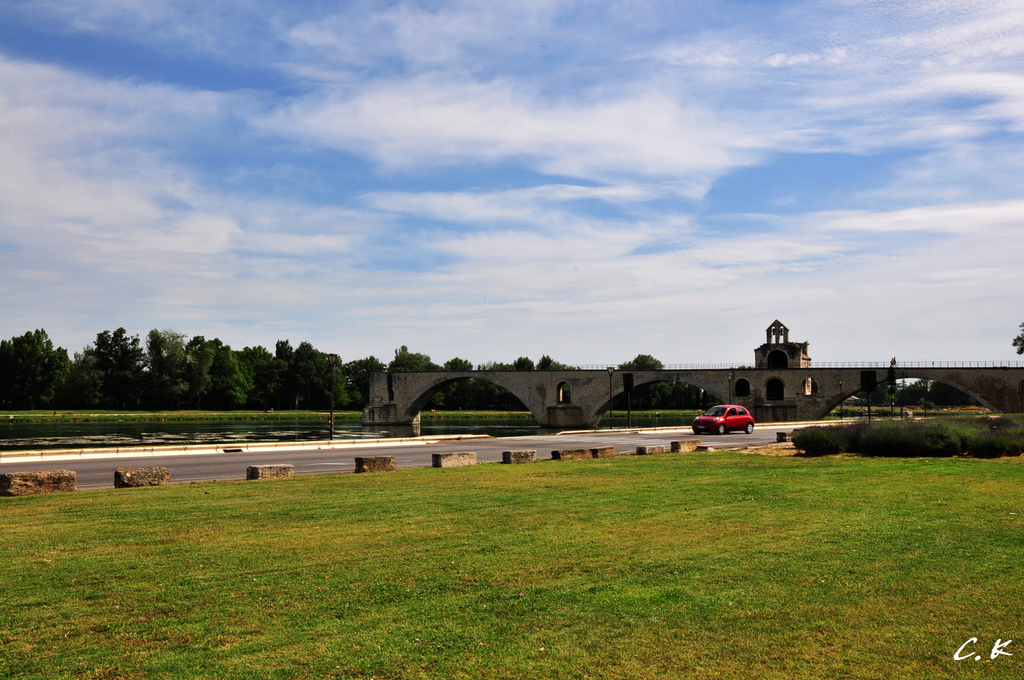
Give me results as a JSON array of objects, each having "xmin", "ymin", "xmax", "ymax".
[{"xmin": 0, "ymin": 328, "xmax": 384, "ymax": 411}]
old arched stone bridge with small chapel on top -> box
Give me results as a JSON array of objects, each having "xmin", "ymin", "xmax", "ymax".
[{"xmin": 362, "ymin": 320, "xmax": 1024, "ymax": 428}]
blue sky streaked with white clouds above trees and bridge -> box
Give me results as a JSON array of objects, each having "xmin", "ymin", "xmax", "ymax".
[{"xmin": 0, "ymin": 0, "xmax": 1024, "ymax": 364}]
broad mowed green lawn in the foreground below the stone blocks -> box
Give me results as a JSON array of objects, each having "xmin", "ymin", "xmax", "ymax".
[{"xmin": 0, "ymin": 452, "xmax": 1024, "ymax": 679}]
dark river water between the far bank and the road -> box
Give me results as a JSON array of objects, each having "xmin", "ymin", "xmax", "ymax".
[{"xmin": 0, "ymin": 411, "xmax": 689, "ymax": 451}]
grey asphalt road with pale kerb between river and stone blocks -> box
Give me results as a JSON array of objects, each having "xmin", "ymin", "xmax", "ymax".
[{"xmin": 0, "ymin": 423, "xmax": 794, "ymax": 490}]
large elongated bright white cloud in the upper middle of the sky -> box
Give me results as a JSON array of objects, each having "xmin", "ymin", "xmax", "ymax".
[{"xmin": 260, "ymin": 77, "xmax": 759, "ymax": 188}]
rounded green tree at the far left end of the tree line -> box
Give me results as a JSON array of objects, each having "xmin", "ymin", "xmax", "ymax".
[{"xmin": 0, "ymin": 329, "xmax": 71, "ymax": 411}]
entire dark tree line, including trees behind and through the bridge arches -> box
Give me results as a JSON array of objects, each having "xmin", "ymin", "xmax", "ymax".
[{"xmin": 0, "ymin": 328, "xmax": 709, "ymax": 411}]
